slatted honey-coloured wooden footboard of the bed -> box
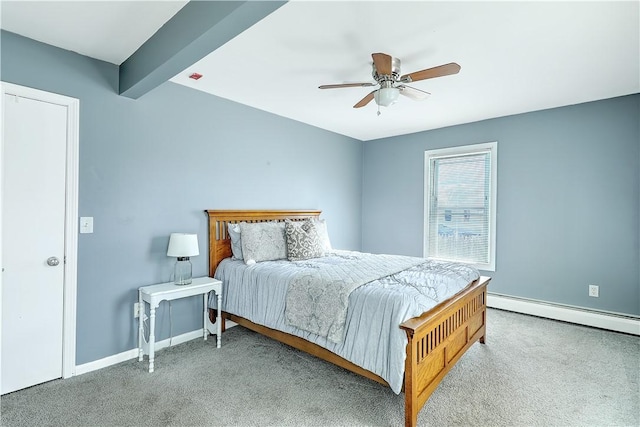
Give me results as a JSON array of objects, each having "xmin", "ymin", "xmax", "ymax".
[{"xmin": 400, "ymin": 277, "xmax": 491, "ymax": 426}]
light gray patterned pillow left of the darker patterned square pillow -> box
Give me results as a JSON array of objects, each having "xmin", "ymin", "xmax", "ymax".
[{"xmin": 240, "ymin": 222, "xmax": 287, "ymax": 264}]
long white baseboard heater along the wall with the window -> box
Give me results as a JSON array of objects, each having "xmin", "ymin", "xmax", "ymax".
[{"xmin": 487, "ymin": 293, "xmax": 640, "ymax": 335}]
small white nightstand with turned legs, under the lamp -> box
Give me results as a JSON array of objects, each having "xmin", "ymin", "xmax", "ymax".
[{"xmin": 138, "ymin": 277, "xmax": 222, "ymax": 372}]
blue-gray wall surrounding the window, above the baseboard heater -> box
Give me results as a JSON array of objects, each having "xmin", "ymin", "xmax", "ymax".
[{"xmin": 362, "ymin": 94, "xmax": 640, "ymax": 315}]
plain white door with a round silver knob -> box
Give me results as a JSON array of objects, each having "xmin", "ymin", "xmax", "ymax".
[{"xmin": 0, "ymin": 90, "xmax": 68, "ymax": 394}]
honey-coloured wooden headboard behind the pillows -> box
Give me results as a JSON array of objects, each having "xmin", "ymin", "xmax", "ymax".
[{"xmin": 205, "ymin": 210, "xmax": 322, "ymax": 277}]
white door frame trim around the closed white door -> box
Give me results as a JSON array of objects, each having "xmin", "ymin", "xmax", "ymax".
[{"xmin": 0, "ymin": 82, "xmax": 80, "ymax": 381}]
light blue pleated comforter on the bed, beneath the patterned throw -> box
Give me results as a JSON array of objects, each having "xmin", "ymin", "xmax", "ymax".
[{"xmin": 210, "ymin": 251, "xmax": 480, "ymax": 394}]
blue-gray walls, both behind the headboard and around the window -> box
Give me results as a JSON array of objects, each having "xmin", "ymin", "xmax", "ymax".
[{"xmin": 0, "ymin": 32, "xmax": 640, "ymax": 364}]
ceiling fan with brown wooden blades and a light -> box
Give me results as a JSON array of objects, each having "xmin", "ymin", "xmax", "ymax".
[{"xmin": 318, "ymin": 53, "xmax": 460, "ymax": 110}]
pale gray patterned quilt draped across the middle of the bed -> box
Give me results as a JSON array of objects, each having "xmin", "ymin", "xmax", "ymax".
[{"xmin": 285, "ymin": 252, "xmax": 425, "ymax": 343}]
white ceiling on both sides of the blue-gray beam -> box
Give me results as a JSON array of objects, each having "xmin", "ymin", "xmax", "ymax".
[{"xmin": 2, "ymin": 1, "xmax": 640, "ymax": 141}]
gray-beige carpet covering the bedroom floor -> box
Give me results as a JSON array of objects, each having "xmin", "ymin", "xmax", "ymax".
[{"xmin": 0, "ymin": 309, "xmax": 640, "ymax": 427}]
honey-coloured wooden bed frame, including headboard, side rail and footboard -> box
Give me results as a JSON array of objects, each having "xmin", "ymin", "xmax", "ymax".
[{"xmin": 205, "ymin": 210, "xmax": 491, "ymax": 426}]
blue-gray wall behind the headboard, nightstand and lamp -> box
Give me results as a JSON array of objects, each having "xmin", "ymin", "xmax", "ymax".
[{"xmin": 0, "ymin": 32, "xmax": 362, "ymax": 364}]
